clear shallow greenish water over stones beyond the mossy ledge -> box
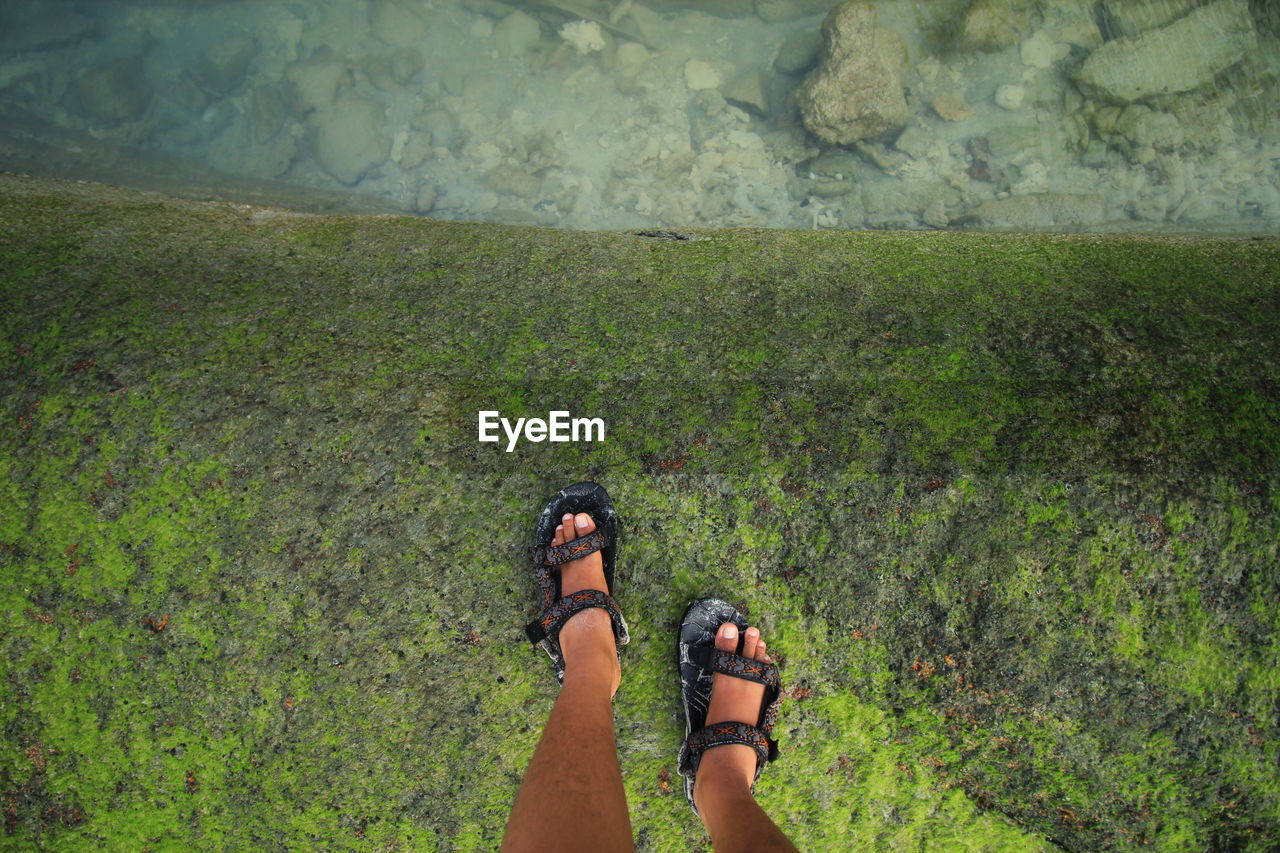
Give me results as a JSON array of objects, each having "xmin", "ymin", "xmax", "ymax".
[{"xmin": 0, "ymin": 0, "xmax": 1280, "ymax": 234}]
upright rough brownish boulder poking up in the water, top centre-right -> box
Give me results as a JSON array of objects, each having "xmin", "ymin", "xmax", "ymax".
[{"xmin": 797, "ymin": 0, "xmax": 910, "ymax": 145}]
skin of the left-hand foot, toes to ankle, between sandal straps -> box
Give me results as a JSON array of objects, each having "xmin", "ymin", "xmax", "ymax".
[{"xmin": 552, "ymin": 512, "xmax": 622, "ymax": 695}]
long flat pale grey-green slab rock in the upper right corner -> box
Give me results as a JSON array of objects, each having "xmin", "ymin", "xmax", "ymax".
[{"xmin": 1079, "ymin": 0, "xmax": 1257, "ymax": 102}]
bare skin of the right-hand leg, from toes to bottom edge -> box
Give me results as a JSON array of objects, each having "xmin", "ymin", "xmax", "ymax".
[{"xmin": 694, "ymin": 622, "xmax": 796, "ymax": 853}]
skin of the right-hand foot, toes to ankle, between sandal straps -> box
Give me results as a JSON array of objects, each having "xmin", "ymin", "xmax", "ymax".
[{"xmin": 694, "ymin": 622, "xmax": 769, "ymax": 809}]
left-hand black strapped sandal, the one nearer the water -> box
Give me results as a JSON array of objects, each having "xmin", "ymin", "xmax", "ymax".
[{"xmin": 525, "ymin": 483, "xmax": 631, "ymax": 684}]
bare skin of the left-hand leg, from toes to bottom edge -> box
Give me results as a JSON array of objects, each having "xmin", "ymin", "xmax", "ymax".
[{"xmin": 502, "ymin": 512, "xmax": 635, "ymax": 853}]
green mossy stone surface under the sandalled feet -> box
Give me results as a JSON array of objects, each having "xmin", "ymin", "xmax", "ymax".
[{"xmin": 0, "ymin": 177, "xmax": 1280, "ymax": 850}]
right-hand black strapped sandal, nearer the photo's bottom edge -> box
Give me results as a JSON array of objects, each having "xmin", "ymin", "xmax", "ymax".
[{"xmin": 677, "ymin": 598, "xmax": 782, "ymax": 815}]
